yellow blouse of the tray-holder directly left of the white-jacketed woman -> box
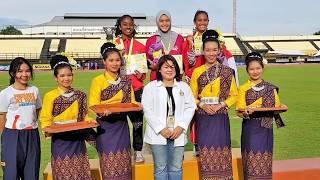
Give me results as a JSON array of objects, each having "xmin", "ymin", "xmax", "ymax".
[{"xmin": 89, "ymin": 73, "xmax": 137, "ymax": 106}]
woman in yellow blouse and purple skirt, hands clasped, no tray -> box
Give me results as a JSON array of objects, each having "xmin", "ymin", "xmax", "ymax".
[{"xmin": 190, "ymin": 30, "xmax": 238, "ymax": 179}]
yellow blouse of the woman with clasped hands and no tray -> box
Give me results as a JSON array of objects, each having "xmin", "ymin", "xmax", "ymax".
[{"xmin": 190, "ymin": 65, "xmax": 238, "ymax": 107}]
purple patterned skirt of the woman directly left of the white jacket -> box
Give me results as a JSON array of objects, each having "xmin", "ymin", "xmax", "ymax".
[{"xmin": 96, "ymin": 114, "xmax": 131, "ymax": 180}]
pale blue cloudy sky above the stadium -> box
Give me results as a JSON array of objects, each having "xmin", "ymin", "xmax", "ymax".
[{"xmin": 0, "ymin": 0, "xmax": 320, "ymax": 35}]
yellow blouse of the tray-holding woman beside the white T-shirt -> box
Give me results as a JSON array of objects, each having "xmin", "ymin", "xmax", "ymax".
[{"xmin": 39, "ymin": 87, "xmax": 90, "ymax": 128}]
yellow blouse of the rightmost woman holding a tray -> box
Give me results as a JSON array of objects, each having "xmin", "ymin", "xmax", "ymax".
[{"xmin": 236, "ymin": 80, "xmax": 281, "ymax": 109}]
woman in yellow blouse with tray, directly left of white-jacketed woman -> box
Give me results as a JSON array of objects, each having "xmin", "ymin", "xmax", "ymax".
[{"xmin": 89, "ymin": 42, "xmax": 142, "ymax": 180}]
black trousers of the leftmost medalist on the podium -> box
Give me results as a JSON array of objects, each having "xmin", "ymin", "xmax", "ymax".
[{"xmin": 128, "ymin": 89, "xmax": 143, "ymax": 151}]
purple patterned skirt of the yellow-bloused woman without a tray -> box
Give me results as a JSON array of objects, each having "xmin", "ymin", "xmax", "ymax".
[{"xmin": 196, "ymin": 113, "xmax": 232, "ymax": 180}]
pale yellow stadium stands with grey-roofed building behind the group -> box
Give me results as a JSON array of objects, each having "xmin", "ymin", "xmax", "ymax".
[{"xmin": 0, "ymin": 13, "xmax": 320, "ymax": 64}]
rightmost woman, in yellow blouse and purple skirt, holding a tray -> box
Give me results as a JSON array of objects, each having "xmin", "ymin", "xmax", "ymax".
[{"xmin": 236, "ymin": 52, "xmax": 284, "ymax": 179}]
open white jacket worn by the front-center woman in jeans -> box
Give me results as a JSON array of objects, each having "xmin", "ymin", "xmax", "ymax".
[{"xmin": 141, "ymin": 80, "xmax": 196, "ymax": 146}]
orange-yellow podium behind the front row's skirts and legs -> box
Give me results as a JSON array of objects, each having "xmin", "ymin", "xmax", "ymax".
[{"xmin": 43, "ymin": 148, "xmax": 320, "ymax": 180}]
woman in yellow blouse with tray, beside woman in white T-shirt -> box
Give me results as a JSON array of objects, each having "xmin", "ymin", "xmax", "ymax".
[{"xmin": 39, "ymin": 55, "xmax": 91, "ymax": 180}]
